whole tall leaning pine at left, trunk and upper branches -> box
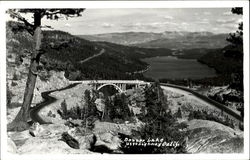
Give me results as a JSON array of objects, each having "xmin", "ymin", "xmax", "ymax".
[{"xmin": 7, "ymin": 9, "xmax": 84, "ymax": 131}]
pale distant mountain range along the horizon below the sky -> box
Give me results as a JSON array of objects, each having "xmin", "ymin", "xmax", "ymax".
[{"xmin": 77, "ymin": 31, "xmax": 228, "ymax": 49}]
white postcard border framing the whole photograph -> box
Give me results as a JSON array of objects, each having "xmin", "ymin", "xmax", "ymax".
[{"xmin": 0, "ymin": 1, "xmax": 250, "ymax": 160}]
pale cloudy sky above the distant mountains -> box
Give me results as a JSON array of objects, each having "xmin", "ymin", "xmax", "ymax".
[{"xmin": 11, "ymin": 8, "xmax": 242, "ymax": 35}]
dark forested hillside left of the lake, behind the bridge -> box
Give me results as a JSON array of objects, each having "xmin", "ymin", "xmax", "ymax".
[{"xmin": 7, "ymin": 22, "xmax": 171, "ymax": 80}]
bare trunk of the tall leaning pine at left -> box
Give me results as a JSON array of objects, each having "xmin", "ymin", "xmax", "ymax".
[{"xmin": 8, "ymin": 12, "xmax": 42, "ymax": 131}]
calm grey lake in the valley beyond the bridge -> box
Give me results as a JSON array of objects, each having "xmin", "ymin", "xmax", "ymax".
[{"xmin": 142, "ymin": 56, "xmax": 216, "ymax": 79}]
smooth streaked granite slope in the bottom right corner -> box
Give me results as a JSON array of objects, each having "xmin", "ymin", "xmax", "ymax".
[{"xmin": 187, "ymin": 120, "xmax": 244, "ymax": 153}]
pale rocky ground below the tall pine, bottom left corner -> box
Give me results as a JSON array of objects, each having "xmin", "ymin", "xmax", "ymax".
[{"xmin": 8, "ymin": 124, "xmax": 93, "ymax": 154}]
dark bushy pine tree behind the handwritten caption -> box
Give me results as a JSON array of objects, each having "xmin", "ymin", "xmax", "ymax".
[{"xmin": 128, "ymin": 83, "xmax": 185, "ymax": 153}]
